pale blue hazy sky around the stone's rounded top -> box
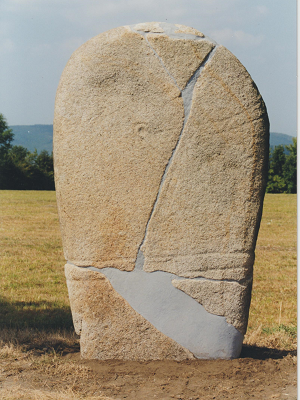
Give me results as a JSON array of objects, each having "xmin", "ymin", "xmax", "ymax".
[{"xmin": 0, "ymin": 0, "xmax": 297, "ymax": 136}]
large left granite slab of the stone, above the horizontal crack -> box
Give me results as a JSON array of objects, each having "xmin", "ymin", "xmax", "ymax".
[{"xmin": 54, "ymin": 28, "xmax": 184, "ymax": 271}]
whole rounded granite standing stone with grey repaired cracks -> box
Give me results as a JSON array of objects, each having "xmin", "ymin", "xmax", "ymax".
[{"xmin": 54, "ymin": 22, "xmax": 269, "ymax": 360}]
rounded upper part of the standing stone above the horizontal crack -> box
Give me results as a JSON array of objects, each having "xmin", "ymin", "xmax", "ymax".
[{"xmin": 54, "ymin": 22, "xmax": 269, "ymax": 279}]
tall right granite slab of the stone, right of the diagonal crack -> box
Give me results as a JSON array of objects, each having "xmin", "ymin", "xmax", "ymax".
[{"xmin": 141, "ymin": 47, "xmax": 269, "ymax": 280}]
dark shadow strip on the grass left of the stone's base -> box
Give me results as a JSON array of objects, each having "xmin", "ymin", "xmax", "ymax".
[{"xmin": 0, "ymin": 297, "xmax": 80, "ymax": 355}]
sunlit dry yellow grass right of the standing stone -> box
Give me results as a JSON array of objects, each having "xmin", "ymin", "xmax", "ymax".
[{"xmin": 245, "ymin": 194, "xmax": 297, "ymax": 349}]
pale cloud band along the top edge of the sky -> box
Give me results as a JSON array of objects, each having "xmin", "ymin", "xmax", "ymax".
[{"xmin": 1, "ymin": 0, "xmax": 239, "ymax": 26}]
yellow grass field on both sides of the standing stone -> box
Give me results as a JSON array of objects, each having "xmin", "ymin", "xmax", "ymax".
[{"xmin": 0, "ymin": 191, "xmax": 297, "ymax": 350}]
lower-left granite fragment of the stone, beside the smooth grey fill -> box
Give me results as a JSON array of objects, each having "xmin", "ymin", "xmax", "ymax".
[{"xmin": 65, "ymin": 264, "xmax": 195, "ymax": 361}]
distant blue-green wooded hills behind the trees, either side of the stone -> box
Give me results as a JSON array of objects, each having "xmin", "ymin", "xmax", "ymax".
[{"xmin": 10, "ymin": 125, "xmax": 293, "ymax": 153}]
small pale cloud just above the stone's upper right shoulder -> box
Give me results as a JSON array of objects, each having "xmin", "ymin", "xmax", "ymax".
[{"xmin": 210, "ymin": 28, "xmax": 264, "ymax": 47}]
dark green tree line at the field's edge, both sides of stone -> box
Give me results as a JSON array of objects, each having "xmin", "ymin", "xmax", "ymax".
[{"xmin": 0, "ymin": 114, "xmax": 297, "ymax": 193}]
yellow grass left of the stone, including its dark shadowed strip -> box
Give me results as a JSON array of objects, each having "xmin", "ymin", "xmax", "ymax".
[{"xmin": 0, "ymin": 191, "xmax": 72, "ymax": 328}]
